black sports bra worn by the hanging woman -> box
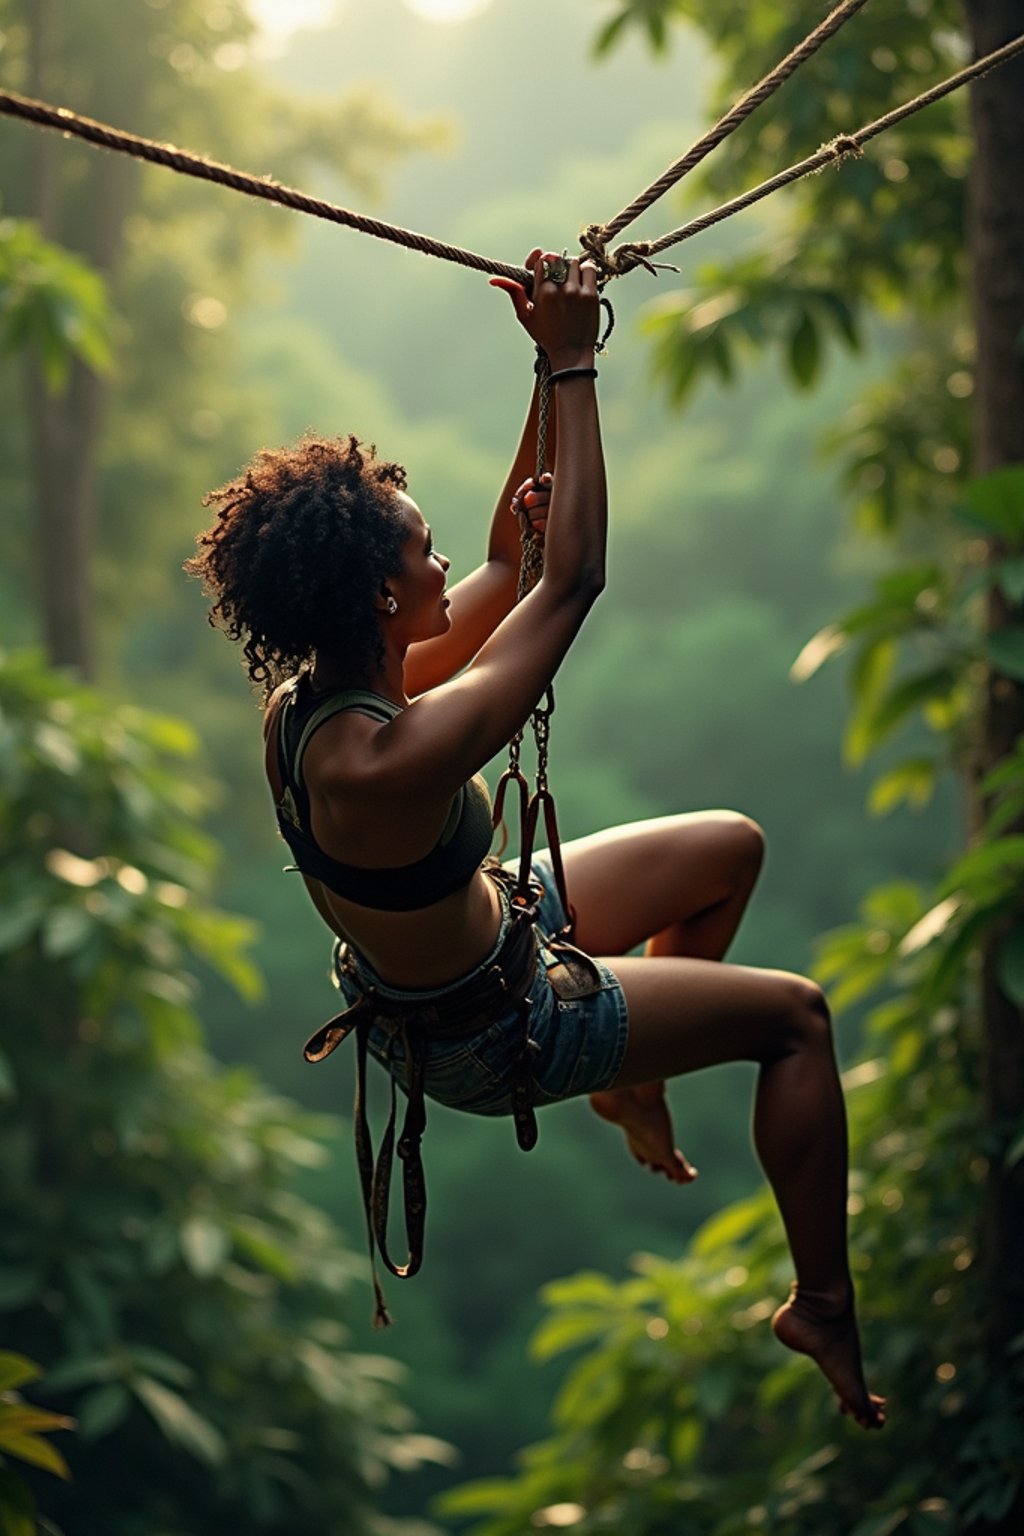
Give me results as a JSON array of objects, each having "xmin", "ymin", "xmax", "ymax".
[{"xmin": 276, "ymin": 677, "xmax": 491, "ymax": 912}]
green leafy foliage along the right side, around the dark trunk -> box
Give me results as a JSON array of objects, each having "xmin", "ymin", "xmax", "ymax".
[{"xmin": 442, "ymin": 0, "xmax": 1024, "ymax": 1536}]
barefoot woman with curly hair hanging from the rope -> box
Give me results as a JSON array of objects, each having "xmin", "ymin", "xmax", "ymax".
[{"xmin": 189, "ymin": 250, "xmax": 884, "ymax": 1427}]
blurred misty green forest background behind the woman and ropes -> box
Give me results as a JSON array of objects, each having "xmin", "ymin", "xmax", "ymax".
[{"xmin": 0, "ymin": 0, "xmax": 1021, "ymax": 1536}]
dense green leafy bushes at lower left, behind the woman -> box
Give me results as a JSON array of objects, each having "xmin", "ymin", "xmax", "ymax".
[{"xmin": 0, "ymin": 654, "xmax": 445, "ymax": 1536}]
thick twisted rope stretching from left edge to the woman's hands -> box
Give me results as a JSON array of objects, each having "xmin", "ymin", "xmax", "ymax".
[{"xmin": 0, "ymin": 91, "xmax": 530, "ymax": 287}]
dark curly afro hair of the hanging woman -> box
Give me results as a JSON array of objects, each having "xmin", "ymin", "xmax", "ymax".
[{"xmin": 184, "ymin": 433, "xmax": 408, "ymax": 699}]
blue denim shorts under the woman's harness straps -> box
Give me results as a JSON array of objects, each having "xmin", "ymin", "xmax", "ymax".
[{"xmin": 332, "ymin": 851, "xmax": 629, "ymax": 1115}]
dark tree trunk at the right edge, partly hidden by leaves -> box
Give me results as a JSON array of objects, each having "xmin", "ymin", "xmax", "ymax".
[{"xmin": 964, "ymin": 0, "xmax": 1024, "ymax": 1536}]
